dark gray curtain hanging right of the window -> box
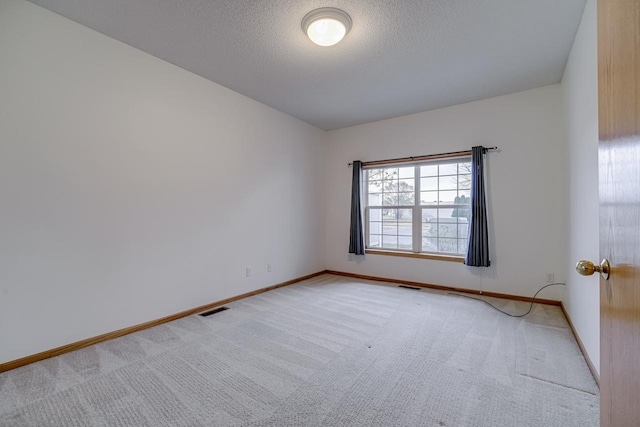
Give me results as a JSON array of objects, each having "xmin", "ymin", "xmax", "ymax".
[{"xmin": 464, "ymin": 146, "xmax": 491, "ymax": 267}]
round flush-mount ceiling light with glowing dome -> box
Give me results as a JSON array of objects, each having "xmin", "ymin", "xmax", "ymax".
[{"xmin": 302, "ymin": 7, "xmax": 351, "ymax": 46}]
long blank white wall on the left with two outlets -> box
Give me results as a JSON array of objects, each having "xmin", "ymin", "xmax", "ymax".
[{"xmin": 0, "ymin": 0, "xmax": 326, "ymax": 363}]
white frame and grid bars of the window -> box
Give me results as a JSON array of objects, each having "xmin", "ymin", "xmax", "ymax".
[{"xmin": 363, "ymin": 155, "xmax": 471, "ymax": 262}]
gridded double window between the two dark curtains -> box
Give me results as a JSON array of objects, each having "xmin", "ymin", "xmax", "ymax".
[{"xmin": 364, "ymin": 156, "xmax": 471, "ymax": 256}]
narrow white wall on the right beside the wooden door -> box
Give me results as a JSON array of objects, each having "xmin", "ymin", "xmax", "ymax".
[{"xmin": 562, "ymin": 0, "xmax": 600, "ymax": 371}]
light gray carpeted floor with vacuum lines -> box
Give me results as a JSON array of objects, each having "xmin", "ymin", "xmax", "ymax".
[{"xmin": 0, "ymin": 275, "xmax": 599, "ymax": 427}]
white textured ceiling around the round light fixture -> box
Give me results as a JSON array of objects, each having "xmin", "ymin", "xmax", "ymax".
[{"xmin": 27, "ymin": 0, "xmax": 586, "ymax": 130}]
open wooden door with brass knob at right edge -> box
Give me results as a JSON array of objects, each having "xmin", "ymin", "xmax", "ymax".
[{"xmin": 596, "ymin": 0, "xmax": 640, "ymax": 427}]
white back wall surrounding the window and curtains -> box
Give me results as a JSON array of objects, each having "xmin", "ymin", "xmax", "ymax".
[{"xmin": 326, "ymin": 85, "xmax": 566, "ymax": 300}]
